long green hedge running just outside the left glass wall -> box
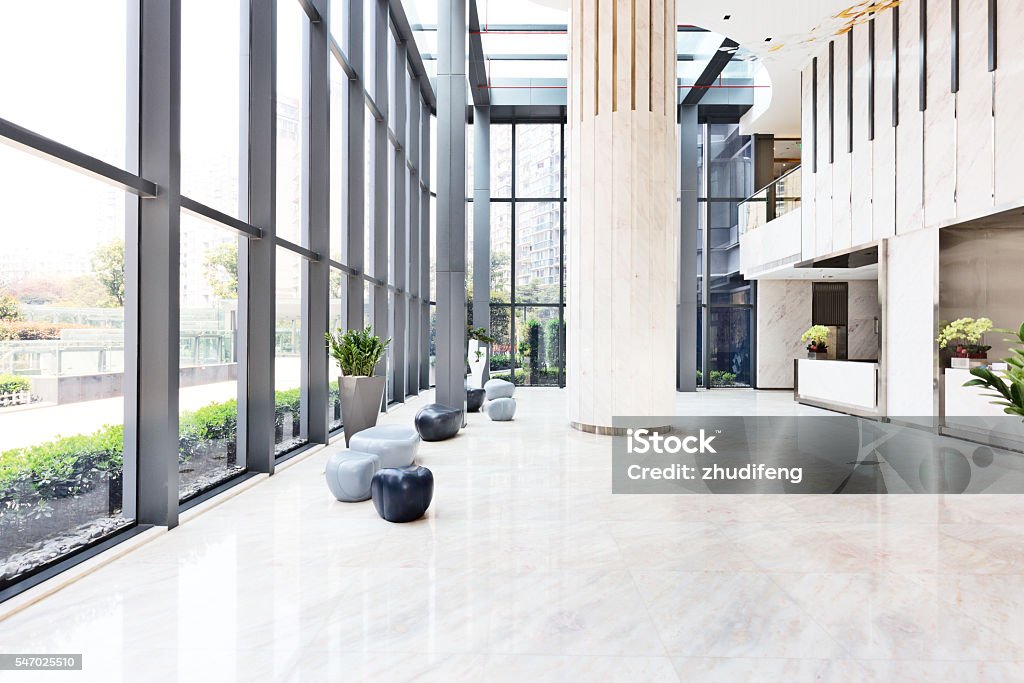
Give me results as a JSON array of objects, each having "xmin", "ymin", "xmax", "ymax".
[{"xmin": 0, "ymin": 385, "xmax": 321, "ymax": 509}]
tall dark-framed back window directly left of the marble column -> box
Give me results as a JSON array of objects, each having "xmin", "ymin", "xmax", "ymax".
[{"xmin": 490, "ymin": 123, "xmax": 565, "ymax": 386}]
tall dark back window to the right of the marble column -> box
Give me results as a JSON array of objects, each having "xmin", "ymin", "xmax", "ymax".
[{"xmin": 697, "ymin": 124, "xmax": 756, "ymax": 387}]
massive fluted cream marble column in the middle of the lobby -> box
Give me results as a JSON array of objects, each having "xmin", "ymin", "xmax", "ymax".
[{"xmin": 566, "ymin": 0, "xmax": 678, "ymax": 431}]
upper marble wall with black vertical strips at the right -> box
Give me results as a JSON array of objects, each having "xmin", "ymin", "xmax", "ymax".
[{"xmin": 803, "ymin": 0, "xmax": 1024, "ymax": 258}]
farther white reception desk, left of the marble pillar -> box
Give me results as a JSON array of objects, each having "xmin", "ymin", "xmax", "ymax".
[{"xmin": 793, "ymin": 358, "xmax": 879, "ymax": 418}]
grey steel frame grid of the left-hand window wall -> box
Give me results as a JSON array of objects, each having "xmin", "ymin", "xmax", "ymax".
[{"xmin": 0, "ymin": 0, "xmax": 436, "ymax": 599}]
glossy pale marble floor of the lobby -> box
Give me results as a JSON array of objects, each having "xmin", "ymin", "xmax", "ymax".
[{"xmin": 0, "ymin": 389, "xmax": 1024, "ymax": 683}]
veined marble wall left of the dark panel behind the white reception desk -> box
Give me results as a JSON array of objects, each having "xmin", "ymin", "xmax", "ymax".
[{"xmin": 758, "ymin": 280, "xmax": 811, "ymax": 389}]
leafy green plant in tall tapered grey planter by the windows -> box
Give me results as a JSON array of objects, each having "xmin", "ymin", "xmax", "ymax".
[{"xmin": 327, "ymin": 326, "xmax": 391, "ymax": 445}]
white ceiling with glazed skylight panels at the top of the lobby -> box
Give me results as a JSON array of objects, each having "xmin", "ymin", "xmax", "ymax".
[{"xmin": 404, "ymin": 0, "xmax": 872, "ymax": 137}]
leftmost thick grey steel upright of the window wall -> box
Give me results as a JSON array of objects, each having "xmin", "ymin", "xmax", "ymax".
[{"xmin": 132, "ymin": 0, "xmax": 181, "ymax": 527}]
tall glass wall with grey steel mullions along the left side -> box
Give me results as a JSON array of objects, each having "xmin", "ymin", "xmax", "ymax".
[{"xmin": 0, "ymin": 0, "xmax": 433, "ymax": 600}]
